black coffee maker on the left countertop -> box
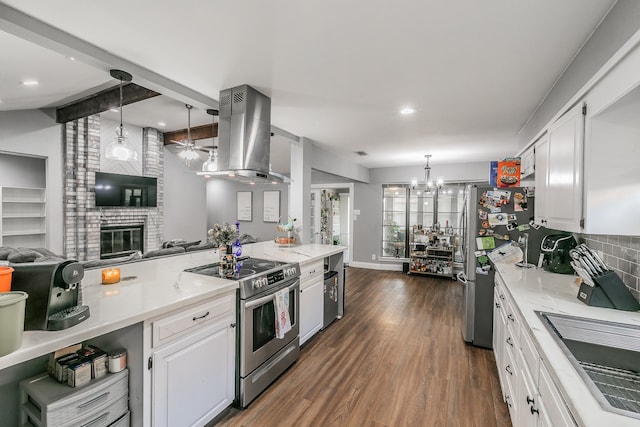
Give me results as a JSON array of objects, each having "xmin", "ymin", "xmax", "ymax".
[{"xmin": 11, "ymin": 260, "xmax": 89, "ymax": 331}]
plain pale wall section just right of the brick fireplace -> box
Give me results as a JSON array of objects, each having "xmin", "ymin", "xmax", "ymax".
[{"xmin": 164, "ymin": 148, "xmax": 207, "ymax": 242}]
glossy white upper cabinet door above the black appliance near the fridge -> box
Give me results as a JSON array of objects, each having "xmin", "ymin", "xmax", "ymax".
[{"xmin": 545, "ymin": 104, "xmax": 584, "ymax": 232}]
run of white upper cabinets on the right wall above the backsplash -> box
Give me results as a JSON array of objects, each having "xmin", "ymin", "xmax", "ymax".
[{"xmin": 534, "ymin": 36, "xmax": 640, "ymax": 236}]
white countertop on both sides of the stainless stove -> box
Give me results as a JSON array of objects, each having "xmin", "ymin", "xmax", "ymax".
[{"xmin": 0, "ymin": 242, "xmax": 346, "ymax": 425}]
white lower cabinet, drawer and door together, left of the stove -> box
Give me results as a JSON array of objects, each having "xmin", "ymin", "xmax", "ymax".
[{"xmin": 145, "ymin": 294, "xmax": 236, "ymax": 427}]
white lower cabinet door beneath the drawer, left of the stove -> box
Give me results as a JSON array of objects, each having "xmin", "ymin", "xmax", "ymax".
[{"xmin": 151, "ymin": 316, "xmax": 235, "ymax": 427}]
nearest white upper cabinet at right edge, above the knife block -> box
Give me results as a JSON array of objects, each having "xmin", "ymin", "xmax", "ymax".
[{"xmin": 583, "ymin": 38, "xmax": 640, "ymax": 236}]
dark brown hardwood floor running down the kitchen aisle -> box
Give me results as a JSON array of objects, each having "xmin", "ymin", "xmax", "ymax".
[{"xmin": 212, "ymin": 267, "xmax": 510, "ymax": 427}]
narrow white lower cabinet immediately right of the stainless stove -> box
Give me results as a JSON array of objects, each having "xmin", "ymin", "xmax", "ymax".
[{"xmin": 300, "ymin": 260, "xmax": 324, "ymax": 345}]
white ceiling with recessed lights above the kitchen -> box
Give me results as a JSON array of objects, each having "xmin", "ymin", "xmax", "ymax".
[{"xmin": 0, "ymin": 0, "xmax": 615, "ymax": 170}]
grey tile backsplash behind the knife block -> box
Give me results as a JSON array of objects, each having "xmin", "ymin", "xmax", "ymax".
[{"xmin": 576, "ymin": 234, "xmax": 640, "ymax": 301}]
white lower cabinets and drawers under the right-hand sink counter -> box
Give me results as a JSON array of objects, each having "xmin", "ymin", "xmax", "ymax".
[{"xmin": 493, "ymin": 275, "xmax": 576, "ymax": 427}]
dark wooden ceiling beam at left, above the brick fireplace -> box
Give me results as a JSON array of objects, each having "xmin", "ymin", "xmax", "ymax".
[{"xmin": 56, "ymin": 83, "xmax": 160, "ymax": 123}]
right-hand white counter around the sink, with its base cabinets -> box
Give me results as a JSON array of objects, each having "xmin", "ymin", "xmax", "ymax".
[{"xmin": 494, "ymin": 264, "xmax": 640, "ymax": 426}]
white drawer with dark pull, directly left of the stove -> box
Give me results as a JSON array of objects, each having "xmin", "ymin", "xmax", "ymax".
[{"xmin": 151, "ymin": 293, "xmax": 236, "ymax": 347}]
